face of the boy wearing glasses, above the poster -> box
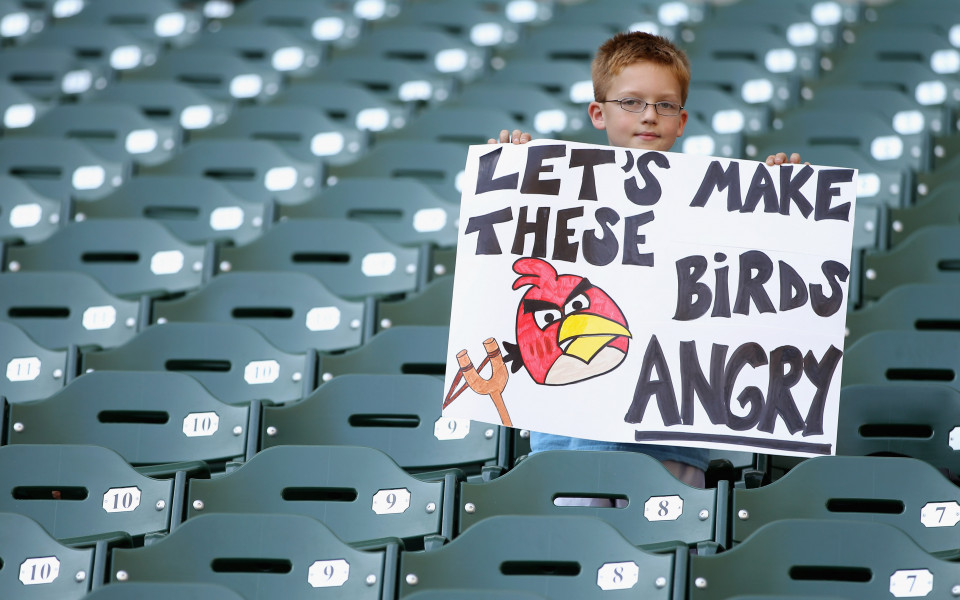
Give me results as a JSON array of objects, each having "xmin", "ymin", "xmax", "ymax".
[{"xmin": 587, "ymin": 61, "xmax": 687, "ymax": 151}]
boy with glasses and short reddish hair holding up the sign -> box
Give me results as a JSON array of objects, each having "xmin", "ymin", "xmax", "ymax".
[{"xmin": 489, "ymin": 32, "xmax": 800, "ymax": 487}]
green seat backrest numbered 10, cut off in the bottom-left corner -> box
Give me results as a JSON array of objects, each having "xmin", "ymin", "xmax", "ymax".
[{"xmin": 0, "ymin": 512, "xmax": 94, "ymax": 600}]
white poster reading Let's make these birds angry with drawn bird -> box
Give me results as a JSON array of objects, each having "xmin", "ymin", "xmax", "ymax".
[{"xmin": 443, "ymin": 140, "xmax": 857, "ymax": 456}]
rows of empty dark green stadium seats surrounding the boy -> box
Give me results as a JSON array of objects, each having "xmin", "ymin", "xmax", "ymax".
[{"xmin": 0, "ymin": 0, "xmax": 960, "ymax": 600}]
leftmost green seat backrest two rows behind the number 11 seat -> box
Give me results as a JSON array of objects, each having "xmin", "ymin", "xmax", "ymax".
[{"xmin": 7, "ymin": 219, "xmax": 205, "ymax": 298}]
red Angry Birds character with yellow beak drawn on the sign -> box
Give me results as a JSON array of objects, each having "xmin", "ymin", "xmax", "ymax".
[{"xmin": 504, "ymin": 258, "xmax": 630, "ymax": 385}]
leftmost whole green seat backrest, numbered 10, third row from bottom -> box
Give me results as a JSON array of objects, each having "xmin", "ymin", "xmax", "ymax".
[{"xmin": 7, "ymin": 371, "xmax": 248, "ymax": 465}]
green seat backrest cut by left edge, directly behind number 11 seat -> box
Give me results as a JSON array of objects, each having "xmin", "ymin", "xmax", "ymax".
[{"xmin": 0, "ymin": 271, "xmax": 140, "ymax": 350}]
